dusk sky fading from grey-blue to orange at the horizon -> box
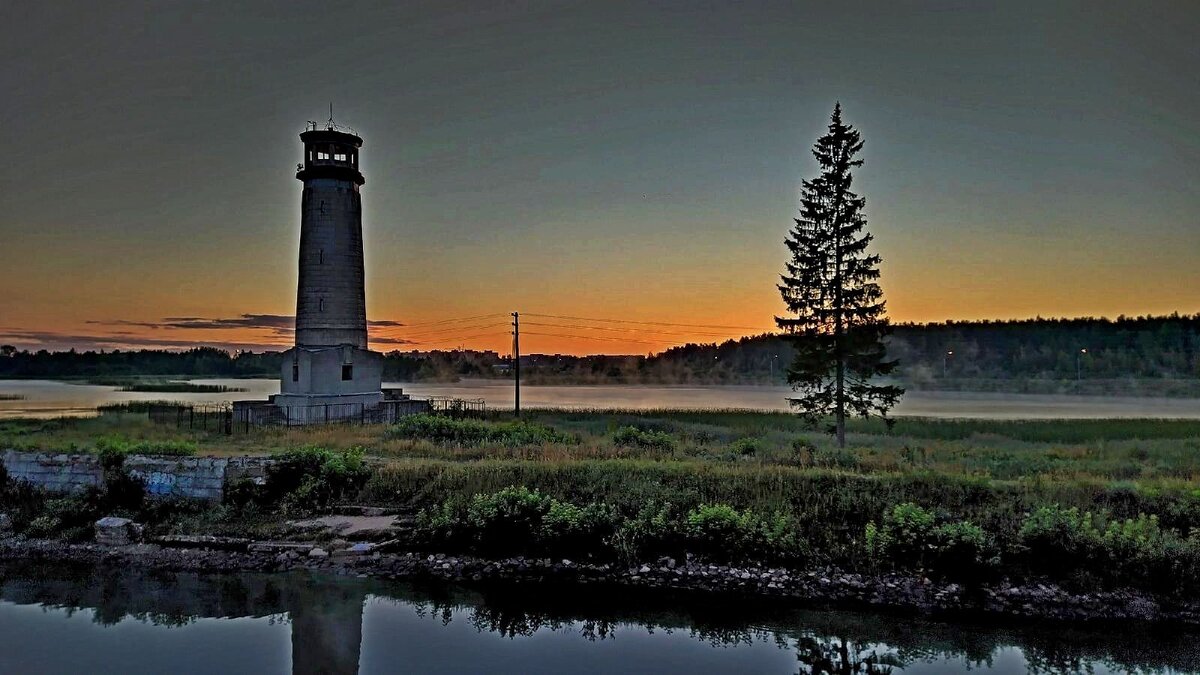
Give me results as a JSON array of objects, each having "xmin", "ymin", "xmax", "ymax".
[{"xmin": 0, "ymin": 0, "xmax": 1200, "ymax": 353}]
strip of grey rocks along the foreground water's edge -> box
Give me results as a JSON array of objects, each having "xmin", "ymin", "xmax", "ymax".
[{"xmin": 0, "ymin": 537, "xmax": 1200, "ymax": 626}]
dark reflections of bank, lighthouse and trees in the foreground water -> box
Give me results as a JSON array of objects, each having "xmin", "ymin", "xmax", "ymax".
[{"xmin": 0, "ymin": 563, "xmax": 1200, "ymax": 675}]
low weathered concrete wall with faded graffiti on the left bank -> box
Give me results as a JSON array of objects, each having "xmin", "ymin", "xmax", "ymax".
[{"xmin": 4, "ymin": 450, "xmax": 271, "ymax": 500}]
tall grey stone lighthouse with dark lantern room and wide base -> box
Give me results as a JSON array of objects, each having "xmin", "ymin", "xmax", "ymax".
[{"xmin": 271, "ymin": 119, "xmax": 383, "ymax": 415}]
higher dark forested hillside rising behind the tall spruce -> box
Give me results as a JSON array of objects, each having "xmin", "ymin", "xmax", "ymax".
[{"xmin": 644, "ymin": 315, "xmax": 1200, "ymax": 394}]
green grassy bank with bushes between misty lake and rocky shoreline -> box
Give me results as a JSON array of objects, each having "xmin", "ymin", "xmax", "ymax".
[{"xmin": 0, "ymin": 411, "xmax": 1200, "ymax": 595}]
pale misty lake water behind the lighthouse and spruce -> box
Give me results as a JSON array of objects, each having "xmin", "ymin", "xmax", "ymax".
[{"xmin": 0, "ymin": 378, "xmax": 1200, "ymax": 419}]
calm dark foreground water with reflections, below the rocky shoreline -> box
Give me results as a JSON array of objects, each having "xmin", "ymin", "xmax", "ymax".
[{"xmin": 0, "ymin": 563, "xmax": 1200, "ymax": 675}]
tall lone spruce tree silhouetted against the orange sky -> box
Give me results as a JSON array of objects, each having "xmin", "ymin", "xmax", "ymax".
[{"xmin": 775, "ymin": 103, "xmax": 904, "ymax": 447}]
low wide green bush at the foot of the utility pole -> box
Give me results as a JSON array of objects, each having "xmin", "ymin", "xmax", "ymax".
[{"xmin": 386, "ymin": 413, "xmax": 575, "ymax": 447}]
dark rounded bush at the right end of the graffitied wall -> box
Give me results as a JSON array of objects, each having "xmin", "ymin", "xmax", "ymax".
[{"xmin": 264, "ymin": 446, "xmax": 371, "ymax": 513}]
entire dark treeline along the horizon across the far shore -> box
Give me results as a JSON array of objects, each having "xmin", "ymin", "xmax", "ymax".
[{"xmin": 0, "ymin": 315, "xmax": 1200, "ymax": 395}]
